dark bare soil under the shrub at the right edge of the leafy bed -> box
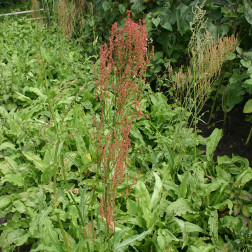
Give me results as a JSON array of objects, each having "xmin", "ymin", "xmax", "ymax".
[{"xmin": 198, "ymin": 103, "xmax": 252, "ymax": 167}]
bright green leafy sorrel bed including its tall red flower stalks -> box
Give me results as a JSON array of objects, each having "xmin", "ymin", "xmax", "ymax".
[{"xmin": 0, "ymin": 3, "xmax": 252, "ymax": 251}]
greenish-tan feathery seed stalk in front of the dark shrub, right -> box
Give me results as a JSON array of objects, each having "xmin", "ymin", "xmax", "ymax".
[{"xmin": 168, "ymin": 1, "xmax": 237, "ymax": 160}]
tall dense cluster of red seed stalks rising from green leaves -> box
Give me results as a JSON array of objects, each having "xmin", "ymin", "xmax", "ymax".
[{"xmin": 94, "ymin": 18, "xmax": 154, "ymax": 232}]
